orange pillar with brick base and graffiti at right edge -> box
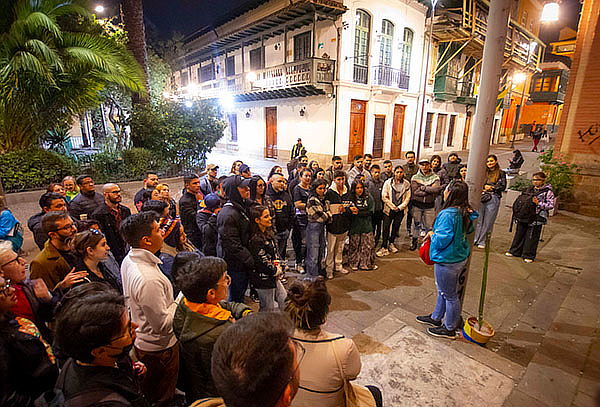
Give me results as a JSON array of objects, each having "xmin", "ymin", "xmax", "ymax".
[{"xmin": 555, "ymin": 0, "xmax": 600, "ymax": 216}]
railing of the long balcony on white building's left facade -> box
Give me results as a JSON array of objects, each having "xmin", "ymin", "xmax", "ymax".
[{"xmin": 179, "ymin": 58, "xmax": 335, "ymax": 99}]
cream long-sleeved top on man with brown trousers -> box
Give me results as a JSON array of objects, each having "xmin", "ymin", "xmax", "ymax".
[{"xmin": 121, "ymin": 248, "xmax": 177, "ymax": 352}]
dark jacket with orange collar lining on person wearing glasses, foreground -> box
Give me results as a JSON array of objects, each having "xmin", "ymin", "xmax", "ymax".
[{"xmin": 173, "ymin": 299, "xmax": 252, "ymax": 400}]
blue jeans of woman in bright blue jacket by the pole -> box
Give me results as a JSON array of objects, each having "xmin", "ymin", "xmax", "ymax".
[{"xmin": 431, "ymin": 259, "xmax": 467, "ymax": 331}]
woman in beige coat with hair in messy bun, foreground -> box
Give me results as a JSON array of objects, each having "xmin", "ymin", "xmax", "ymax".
[{"xmin": 285, "ymin": 277, "xmax": 381, "ymax": 407}]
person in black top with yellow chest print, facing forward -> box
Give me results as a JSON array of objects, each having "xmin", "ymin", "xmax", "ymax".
[{"xmin": 267, "ymin": 173, "xmax": 294, "ymax": 261}]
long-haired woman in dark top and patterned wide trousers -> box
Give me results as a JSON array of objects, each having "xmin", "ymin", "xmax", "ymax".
[{"xmin": 348, "ymin": 180, "xmax": 377, "ymax": 271}]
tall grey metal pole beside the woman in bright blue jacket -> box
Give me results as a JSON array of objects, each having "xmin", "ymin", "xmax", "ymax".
[{"xmin": 458, "ymin": 0, "xmax": 511, "ymax": 306}]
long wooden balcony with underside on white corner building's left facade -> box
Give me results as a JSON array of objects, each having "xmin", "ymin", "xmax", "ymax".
[{"xmin": 179, "ymin": 58, "xmax": 335, "ymax": 101}]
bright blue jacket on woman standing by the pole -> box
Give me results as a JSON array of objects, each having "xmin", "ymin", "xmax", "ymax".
[{"xmin": 429, "ymin": 207, "xmax": 479, "ymax": 263}]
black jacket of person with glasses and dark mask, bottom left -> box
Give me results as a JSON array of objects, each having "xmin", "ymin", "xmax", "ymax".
[{"xmin": 57, "ymin": 358, "xmax": 150, "ymax": 407}]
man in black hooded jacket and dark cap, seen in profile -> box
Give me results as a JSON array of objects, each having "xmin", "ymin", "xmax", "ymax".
[{"xmin": 217, "ymin": 175, "xmax": 254, "ymax": 302}]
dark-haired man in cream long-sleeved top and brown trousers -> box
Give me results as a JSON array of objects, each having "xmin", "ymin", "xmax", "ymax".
[{"xmin": 121, "ymin": 211, "xmax": 179, "ymax": 406}]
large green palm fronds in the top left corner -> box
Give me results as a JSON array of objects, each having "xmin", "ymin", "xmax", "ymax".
[{"xmin": 0, "ymin": 0, "xmax": 145, "ymax": 152}]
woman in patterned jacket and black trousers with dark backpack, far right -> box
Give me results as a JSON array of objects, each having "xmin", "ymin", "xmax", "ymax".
[{"xmin": 506, "ymin": 172, "xmax": 554, "ymax": 263}]
